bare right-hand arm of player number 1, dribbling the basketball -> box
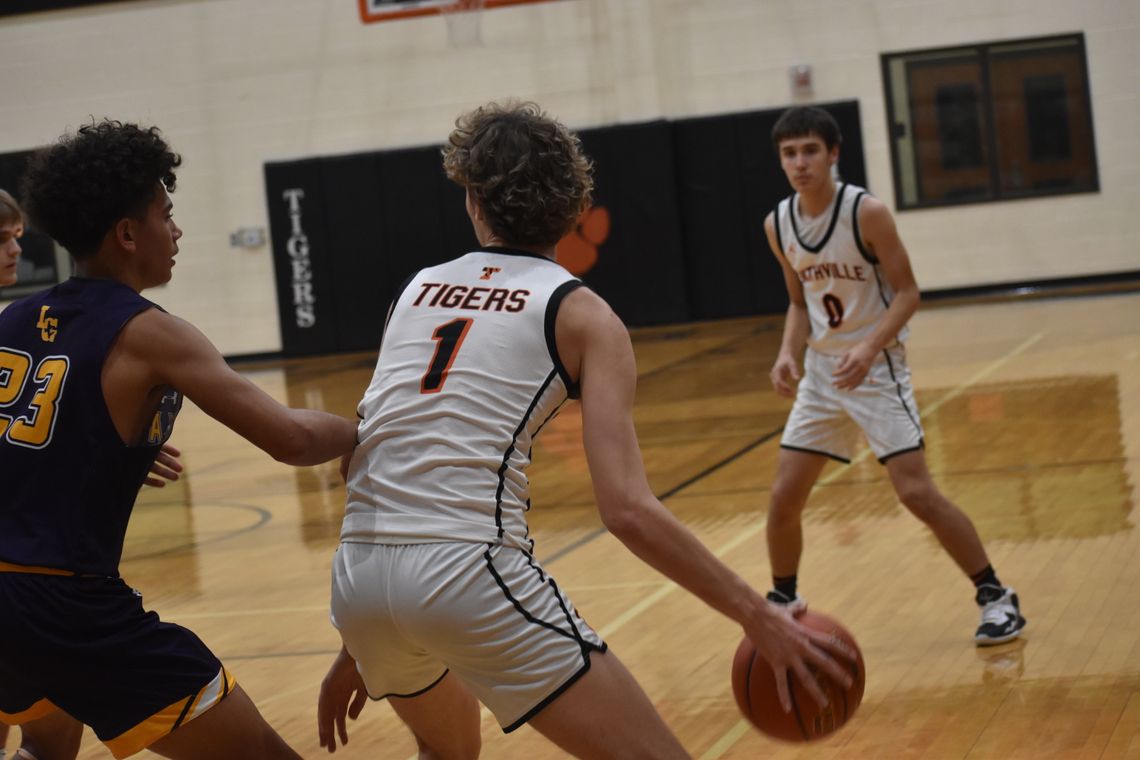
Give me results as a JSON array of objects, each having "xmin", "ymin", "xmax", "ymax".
[{"xmin": 556, "ymin": 288, "xmax": 849, "ymax": 710}]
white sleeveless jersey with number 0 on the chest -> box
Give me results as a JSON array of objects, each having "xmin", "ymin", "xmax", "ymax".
[{"xmin": 775, "ymin": 183, "xmax": 906, "ymax": 354}]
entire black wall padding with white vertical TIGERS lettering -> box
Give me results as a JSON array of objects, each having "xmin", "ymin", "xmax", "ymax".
[{"xmin": 266, "ymin": 101, "xmax": 866, "ymax": 356}]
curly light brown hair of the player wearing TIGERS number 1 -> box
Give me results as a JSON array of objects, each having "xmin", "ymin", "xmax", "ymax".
[{"xmin": 442, "ymin": 100, "xmax": 594, "ymax": 246}]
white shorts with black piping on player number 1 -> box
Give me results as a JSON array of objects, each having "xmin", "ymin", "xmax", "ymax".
[{"xmin": 332, "ymin": 542, "xmax": 606, "ymax": 732}]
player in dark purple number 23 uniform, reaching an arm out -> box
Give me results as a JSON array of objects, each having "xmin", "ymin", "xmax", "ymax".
[{"xmin": 0, "ymin": 121, "xmax": 356, "ymax": 760}]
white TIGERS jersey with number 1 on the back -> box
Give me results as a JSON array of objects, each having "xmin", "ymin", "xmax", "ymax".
[{"xmin": 341, "ymin": 248, "xmax": 581, "ymax": 551}]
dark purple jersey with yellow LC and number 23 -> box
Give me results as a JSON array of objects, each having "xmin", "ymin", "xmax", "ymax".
[{"xmin": 0, "ymin": 277, "xmax": 181, "ymax": 577}]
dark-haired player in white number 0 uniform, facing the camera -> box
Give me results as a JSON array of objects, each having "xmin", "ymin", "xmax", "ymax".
[{"xmin": 764, "ymin": 107, "xmax": 1025, "ymax": 646}]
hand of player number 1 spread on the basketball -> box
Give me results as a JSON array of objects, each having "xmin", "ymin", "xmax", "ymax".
[{"xmin": 746, "ymin": 605, "xmax": 855, "ymax": 712}]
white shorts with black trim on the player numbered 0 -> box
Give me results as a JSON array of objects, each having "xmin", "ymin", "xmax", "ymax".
[{"xmin": 780, "ymin": 345, "xmax": 922, "ymax": 461}]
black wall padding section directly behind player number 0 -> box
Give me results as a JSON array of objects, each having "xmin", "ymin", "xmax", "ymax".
[{"xmin": 674, "ymin": 101, "xmax": 865, "ymax": 319}]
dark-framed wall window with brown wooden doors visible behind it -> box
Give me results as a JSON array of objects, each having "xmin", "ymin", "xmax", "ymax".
[{"xmin": 882, "ymin": 34, "xmax": 1099, "ymax": 210}]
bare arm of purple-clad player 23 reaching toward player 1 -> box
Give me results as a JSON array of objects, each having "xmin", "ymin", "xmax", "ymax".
[{"xmin": 103, "ymin": 309, "xmax": 356, "ymax": 465}]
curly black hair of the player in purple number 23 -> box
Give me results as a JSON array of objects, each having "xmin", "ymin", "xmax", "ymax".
[{"xmin": 23, "ymin": 119, "xmax": 182, "ymax": 259}]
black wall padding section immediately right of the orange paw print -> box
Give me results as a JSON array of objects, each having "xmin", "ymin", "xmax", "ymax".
[{"xmin": 579, "ymin": 121, "xmax": 691, "ymax": 325}]
